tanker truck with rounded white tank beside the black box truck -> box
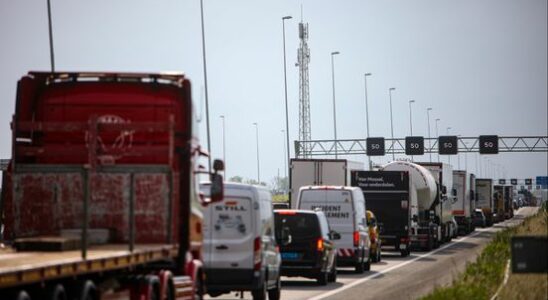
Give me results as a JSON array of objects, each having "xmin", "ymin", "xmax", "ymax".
[{"xmin": 378, "ymin": 161, "xmax": 443, "ymax": 250}]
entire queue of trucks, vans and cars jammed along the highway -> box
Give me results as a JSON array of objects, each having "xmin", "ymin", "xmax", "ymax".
[{"xmin": 0, "ymin": 72, "xmax": 515, "ymax": 300}]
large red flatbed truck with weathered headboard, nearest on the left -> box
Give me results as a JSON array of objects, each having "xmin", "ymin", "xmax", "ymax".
[{"xmin": 0, "ymin": 72, "xmax": 223, "ymax": 300}]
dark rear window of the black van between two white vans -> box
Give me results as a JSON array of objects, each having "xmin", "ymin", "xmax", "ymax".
[{"xmin": 274, "ymin": 213, "xmax": 321, "ymax": 241}]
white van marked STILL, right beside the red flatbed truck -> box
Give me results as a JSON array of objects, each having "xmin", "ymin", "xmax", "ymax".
[{"xmin": 200, "ymin": 183, "xmax": 281, "ymax": 300}]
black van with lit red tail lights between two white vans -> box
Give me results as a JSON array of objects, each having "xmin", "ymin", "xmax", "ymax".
[{"xmin": 274, "ymin": 209, "xmax": 340, "ymax": 285}]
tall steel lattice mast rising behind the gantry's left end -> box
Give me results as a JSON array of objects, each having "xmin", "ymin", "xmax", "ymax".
[{"xmin": 295, "ymin": 17, "xmax": 311, "ymax": 158}]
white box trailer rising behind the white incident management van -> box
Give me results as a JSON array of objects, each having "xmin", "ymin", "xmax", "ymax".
[{"xmin": 289, "ymin": 158, "xmax": 365, "ymax": 208}]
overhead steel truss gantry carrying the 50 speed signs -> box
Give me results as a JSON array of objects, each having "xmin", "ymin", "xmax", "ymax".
[{"xmin": 295, "ymin": 135, "xmax": 548, "ymax": 158}]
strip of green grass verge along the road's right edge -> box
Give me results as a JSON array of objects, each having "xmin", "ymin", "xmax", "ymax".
[{"xmin": 421, "ymin": 212, "xmax": 544, "ymax": 300}]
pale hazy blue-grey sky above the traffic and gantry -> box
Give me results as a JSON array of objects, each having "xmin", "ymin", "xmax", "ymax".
[{"xmin": 0, "ymin": 0, "xmax": 548, "ymax": 182}]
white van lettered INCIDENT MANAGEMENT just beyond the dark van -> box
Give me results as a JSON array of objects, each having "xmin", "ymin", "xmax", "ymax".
[{"xmin": 297, "ymin": 186, "xmax": 371, "ymax": 273}]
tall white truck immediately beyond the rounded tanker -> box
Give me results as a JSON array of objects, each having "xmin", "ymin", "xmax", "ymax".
[{"xmin": 418, "ymin": 162, "xmax": 457, "ymax": 242}]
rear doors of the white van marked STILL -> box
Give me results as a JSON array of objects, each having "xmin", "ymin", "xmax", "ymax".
[{"xmin": 204, "ymin": 195, "xmax": 255, "ymax": 274}]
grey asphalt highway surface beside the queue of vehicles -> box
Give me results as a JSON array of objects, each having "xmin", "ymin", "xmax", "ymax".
[{"xmin": 206, "ymin": 207, "xmax": 538, "ymax": 300}]
